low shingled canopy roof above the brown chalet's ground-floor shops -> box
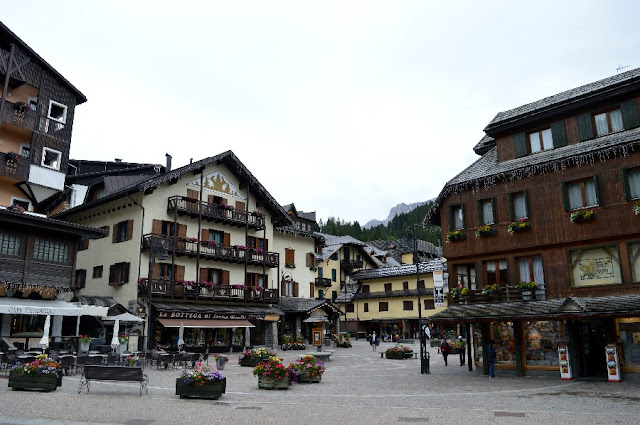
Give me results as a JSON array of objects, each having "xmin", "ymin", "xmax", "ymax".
[{"xmin": 429, "ymin": 294, "xmax": 640, "ymax": 322}]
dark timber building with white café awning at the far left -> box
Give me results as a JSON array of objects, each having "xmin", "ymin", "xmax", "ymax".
[{"xmin": 0, "ymin": 22, "xmax": 104, "ymax": 351}]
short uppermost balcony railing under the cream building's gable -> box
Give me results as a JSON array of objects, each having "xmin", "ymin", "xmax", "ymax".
[{"xmin": 167, "ymin": 196, "xmax": 265, "ymax": 230}]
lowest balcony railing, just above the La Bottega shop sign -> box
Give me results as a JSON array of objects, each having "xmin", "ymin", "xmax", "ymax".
[{"xmin": 138, "ymin": 279, "xmax": 278, "ymax": 304}]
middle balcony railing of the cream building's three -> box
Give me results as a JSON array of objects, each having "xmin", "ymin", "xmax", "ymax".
[{"xmin": 143, "ymin": 234, "xmax": 280, "ymax": 268}]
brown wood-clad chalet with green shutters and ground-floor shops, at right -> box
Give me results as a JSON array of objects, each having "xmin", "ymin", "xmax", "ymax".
[{"xmin": 426, "ymin": 69, "xmax": 640, "ymax": 379}]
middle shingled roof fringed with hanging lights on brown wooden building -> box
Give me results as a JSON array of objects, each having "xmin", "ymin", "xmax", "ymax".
[{"xmin": 425, "ymin": 127, "xmax": 640, "ymax": 224}]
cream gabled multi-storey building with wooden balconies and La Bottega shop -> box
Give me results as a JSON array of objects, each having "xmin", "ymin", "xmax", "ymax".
[{"xmin": 59, "ymin": 151, "xmax": 304, "ymax": 351}]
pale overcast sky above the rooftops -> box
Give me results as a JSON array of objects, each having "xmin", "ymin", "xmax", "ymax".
[{"xmin": 0, "ymin": 0, "xmax": 640, "ymax": 225}]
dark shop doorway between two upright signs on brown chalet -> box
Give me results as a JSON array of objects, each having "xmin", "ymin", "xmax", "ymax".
[{"xmin": 576, "ymin": 320, "xmax": 613, "ymax": 379}]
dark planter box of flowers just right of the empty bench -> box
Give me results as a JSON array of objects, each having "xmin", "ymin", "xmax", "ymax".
[{"xmin": 176, "ymin": 362, "xmax": 227, "ymax": 400}]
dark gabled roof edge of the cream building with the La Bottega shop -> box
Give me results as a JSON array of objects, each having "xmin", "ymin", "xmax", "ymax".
[{"xmin": 56, "ymin": 151, "xmax": 292, "ymax": 225}]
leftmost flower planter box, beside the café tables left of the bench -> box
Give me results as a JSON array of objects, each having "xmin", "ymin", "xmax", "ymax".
[{"xmin": 9, "ymin": 354, "xmax": 62, "ymax": 392}]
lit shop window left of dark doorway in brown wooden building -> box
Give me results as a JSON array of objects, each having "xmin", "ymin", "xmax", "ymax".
[{"xmin": 524, "ymin": 321, "xmax": 569, "ymax": 366}]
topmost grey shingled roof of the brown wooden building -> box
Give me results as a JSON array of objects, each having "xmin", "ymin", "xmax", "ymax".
[{"xmin": 484, "ymin": 68, "xmax": 640, "ymax": 135}]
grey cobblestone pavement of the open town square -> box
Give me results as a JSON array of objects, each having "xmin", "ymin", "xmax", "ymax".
[{"xmin": 0, "ymin": 341, "xmax": 640, "ymax": 425}]
